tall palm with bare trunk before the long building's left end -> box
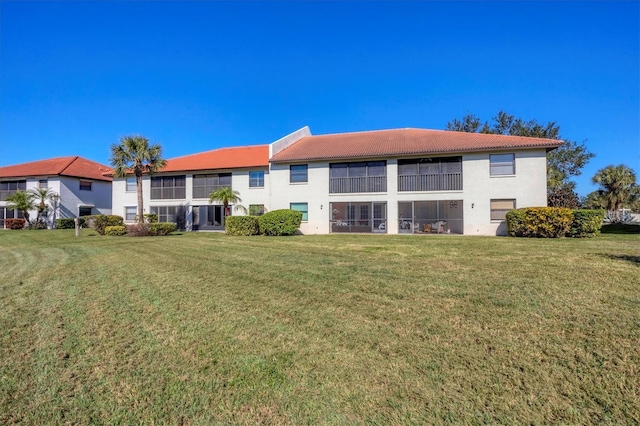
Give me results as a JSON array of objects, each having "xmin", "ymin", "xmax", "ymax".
[{"xmin": 110, "ymin": 135, "xmax": 167, "ymax": 223}]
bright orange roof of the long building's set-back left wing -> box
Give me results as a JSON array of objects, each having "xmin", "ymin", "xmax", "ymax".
[{"xmin": 161, "ymin": 145, "xmax": 269, "ymax": 173}]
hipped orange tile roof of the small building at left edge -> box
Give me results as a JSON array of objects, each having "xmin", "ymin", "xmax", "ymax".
[{"xmin": 0, "ymin": 155, "xmax": 111, "ymax": 181}]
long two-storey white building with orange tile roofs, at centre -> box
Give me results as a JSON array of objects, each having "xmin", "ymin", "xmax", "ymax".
[{"xmin": 113, "ymin": 127, "xmax": 562, "ymax": 235}]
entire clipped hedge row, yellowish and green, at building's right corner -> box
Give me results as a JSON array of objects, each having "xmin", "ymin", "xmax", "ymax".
[{"xmin": 507, "ymin": 207, "xmax": 604, "ymax": 238}]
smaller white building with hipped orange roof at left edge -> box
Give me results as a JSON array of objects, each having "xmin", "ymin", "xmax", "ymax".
[{"xmin": 0, "ymin": 156, "xmax": 112, "ymax": 229}]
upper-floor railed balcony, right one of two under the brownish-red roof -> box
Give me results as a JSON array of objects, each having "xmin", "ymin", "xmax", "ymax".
[{"xmin": 398, "ymin": 157, "xmax": 462, "ymax": 192}]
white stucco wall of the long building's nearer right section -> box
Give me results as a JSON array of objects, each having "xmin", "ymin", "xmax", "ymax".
[{"xmin": 270, "ymin": 149, "xmax": 547, "ymax": 235}]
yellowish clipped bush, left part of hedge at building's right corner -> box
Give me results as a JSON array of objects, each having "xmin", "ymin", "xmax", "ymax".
[{"xmin": 507, "ymin": 207, "xmax": 573, "ymax": 238}]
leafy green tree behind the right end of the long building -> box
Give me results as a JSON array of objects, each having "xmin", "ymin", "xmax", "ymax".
[{"xmin": 447, "ymin": 111, "xmax": 595, "ymax": 195}]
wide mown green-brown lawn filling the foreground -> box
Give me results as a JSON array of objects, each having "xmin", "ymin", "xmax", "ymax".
[{"xmin": 0, "ymin": 230, "xmax": 640, "ymax": 425}]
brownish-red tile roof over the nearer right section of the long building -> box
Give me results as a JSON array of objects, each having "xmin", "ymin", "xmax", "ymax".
[{"xmin": 270, "ymin": 129, "xmax": 562, "ymax": 163}]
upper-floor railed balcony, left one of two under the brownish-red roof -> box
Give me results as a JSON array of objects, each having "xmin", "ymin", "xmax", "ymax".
[{"xmin": 329, "ymin": 161, "xmax": 387, "ymax": 194}]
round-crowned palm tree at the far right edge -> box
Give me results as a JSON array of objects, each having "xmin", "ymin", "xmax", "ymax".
[{"xmin": 592, "ymin": 164, "xmax": 637, "ymax": 219}]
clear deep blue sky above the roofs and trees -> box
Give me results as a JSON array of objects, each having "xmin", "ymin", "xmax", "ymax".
[{"xmin": 0, "ymin": 1, "xmax": 640, "ymax": 195}]
